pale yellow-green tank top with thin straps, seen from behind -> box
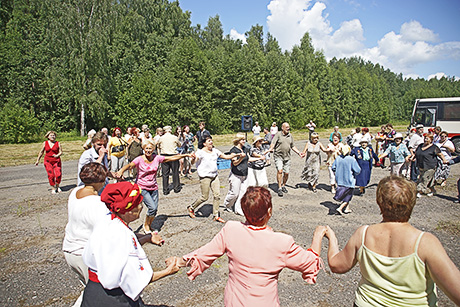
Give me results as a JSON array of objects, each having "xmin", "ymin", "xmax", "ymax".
[{"xmin": 355, "ymin": 226, "xmax": 437, "ymax": 307}]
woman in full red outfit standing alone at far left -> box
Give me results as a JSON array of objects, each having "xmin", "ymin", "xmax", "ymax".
[{"xmin": 35, "ymin": 131, "xmax": 62, "ymax": 194}]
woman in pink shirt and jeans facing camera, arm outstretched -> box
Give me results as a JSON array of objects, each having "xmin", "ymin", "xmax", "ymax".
[{"xmin": 117, "ymin": 140, "xmax": 192, "ymax": 234}]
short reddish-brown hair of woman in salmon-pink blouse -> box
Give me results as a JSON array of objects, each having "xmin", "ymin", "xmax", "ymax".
[{"xmin": 241, "ymin": 187, "xmax": 272, "ymax": 226}]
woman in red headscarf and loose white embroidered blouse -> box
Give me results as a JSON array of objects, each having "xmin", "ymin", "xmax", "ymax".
[{"xmin": 82, "ymin": 182, "xmax": 179, "ymax": 307}]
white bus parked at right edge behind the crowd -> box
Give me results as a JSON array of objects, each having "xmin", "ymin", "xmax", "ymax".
[{"xmin": 411, "ymin": 97, "xmax": 460, "ymax": 154}]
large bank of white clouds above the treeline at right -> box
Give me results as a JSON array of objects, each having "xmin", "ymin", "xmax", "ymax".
[{"xmin": 267, "ymin": 0, "xmax": 460, "ymax": 78}]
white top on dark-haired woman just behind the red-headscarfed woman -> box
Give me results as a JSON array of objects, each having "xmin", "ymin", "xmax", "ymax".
[{"xmin": 62, "ymin": 186, "xmax": 110, "ymax": 256}]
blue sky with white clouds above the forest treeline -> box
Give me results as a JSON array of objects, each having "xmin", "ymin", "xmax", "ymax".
[{"xmin": 179, "ymin": 0, "xmax": 460, "ymax": 79}]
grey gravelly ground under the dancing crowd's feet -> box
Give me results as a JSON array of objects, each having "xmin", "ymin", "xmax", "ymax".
[{"xmin": 0, "ymin": 140, "xmax": 460, "ymax": 307}]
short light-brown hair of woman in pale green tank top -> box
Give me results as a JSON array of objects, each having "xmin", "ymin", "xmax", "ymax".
[{"xmin": 376, "ymin": 175, "xmax": 417, "ymax": 223}]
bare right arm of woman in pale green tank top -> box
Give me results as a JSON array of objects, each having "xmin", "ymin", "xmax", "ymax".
[{"xmin": 418, "ymin": 233, "xmax": 460, "ymax": 306}]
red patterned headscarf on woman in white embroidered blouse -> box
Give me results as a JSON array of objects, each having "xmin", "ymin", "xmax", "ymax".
[{"xmin": 101, "ymin": 181, "xmax": 143, "ymax": 214}]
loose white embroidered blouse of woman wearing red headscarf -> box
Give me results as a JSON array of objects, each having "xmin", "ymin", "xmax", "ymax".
[{"xmin": 83, "ymin": 218, "xmax": 153, "ymax": 301}]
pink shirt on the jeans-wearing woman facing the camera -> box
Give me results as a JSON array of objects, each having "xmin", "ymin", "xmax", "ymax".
[{"xmin": 133, "ymin": 155, "xmax": 165, "ymax": 191}]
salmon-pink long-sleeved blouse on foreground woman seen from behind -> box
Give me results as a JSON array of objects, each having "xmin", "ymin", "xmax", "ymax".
[{"xmin": 183, "ymin": 221, "xmax": 322, "ymax": 307}]
